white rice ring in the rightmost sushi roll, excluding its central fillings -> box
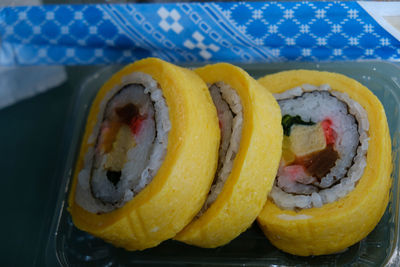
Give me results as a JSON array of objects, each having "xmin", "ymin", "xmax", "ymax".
[{"xmin": 269, "ymin": 85, "xmax": 369, "ymax": 209}]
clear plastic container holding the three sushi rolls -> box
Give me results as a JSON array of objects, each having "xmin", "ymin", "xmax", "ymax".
[{"xmin": 45, "ymin": 62, "xmax": 400, "ymax": 266}]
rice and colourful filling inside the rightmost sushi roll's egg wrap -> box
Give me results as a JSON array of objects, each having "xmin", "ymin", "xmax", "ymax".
[{"xmin": 269, "ymin": 85, "xmax": 369, "ymax": 210}]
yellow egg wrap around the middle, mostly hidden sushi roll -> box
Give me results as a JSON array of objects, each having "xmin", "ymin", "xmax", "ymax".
[{"xmin": 174, "ymin": 63, "xmax": 283, "ymax": 248}]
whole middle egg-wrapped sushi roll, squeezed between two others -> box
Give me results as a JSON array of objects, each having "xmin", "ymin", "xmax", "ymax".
[{"xmin": 175, "ymin": 63, "xmax": 282, "ymax": 248}]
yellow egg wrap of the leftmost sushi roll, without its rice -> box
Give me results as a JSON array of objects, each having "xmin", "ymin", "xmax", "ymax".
[{"xmin": 69, "ymin": 58, "xmax": 220, "ymax": 250}]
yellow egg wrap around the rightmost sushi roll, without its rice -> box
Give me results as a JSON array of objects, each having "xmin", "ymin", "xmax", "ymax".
[{"xmin": 258, "ymin": 70, "xmax": 392, "ymax": 256}]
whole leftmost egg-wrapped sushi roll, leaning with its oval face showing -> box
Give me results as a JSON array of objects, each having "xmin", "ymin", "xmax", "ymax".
[{"xmin": 69, "ymin": 58, "xmax": 220, "ymax": 250}]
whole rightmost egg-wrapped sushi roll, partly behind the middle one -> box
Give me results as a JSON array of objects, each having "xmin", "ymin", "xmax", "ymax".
[{"xmin": 258, "ymin": 70, "xmax": 392, "ymax": 256}]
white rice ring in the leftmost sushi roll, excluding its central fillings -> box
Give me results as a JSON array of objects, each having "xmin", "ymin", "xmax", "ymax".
[{"xmin": 75, "ymin": 72, "xmax": 171, "ymax": 213}]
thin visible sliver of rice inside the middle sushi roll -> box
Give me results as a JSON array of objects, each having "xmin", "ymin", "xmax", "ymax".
[{"xmin": 197, "ymin": 82, "xmax": 243, "ymax": 217}]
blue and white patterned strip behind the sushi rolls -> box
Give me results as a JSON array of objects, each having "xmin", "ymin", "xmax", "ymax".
[{"xmin": 0, "ymin": 2, "xmax": 400, "ymax": 66}]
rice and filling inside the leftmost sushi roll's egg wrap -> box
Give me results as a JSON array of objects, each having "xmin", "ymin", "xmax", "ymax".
[{"xmin": 75, "ymin": 73, "xmax": 171, "ymax": 214}]
